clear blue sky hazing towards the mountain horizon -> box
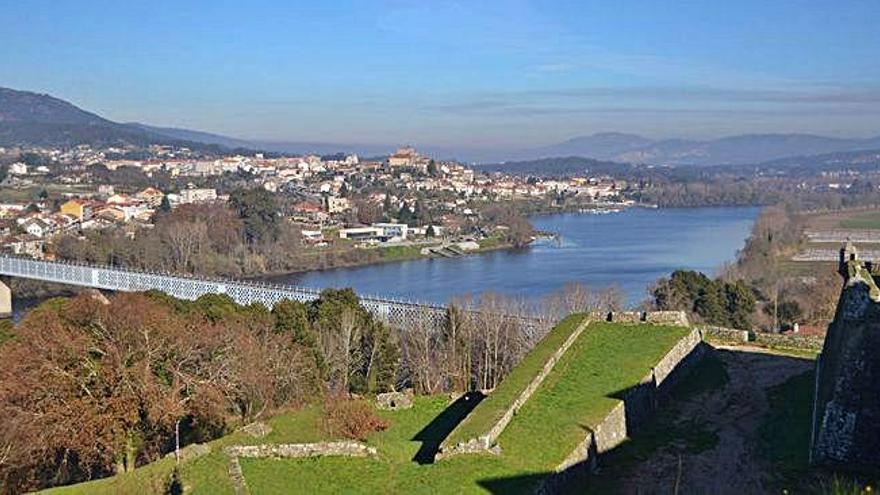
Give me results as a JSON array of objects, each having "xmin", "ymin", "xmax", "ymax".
[{"xmin": 0, "ymin": 0, "xmax": 880, "ymax": 147}]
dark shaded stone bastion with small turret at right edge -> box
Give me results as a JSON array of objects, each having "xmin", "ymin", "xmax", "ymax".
[{"xmin": 810, "ymin": 243, "xmax": 880, "ymax": 471}]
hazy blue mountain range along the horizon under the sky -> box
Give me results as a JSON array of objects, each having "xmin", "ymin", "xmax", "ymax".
[{"xmin": 0, "ymin": 88, "xmax": 880, "ymax": 165}]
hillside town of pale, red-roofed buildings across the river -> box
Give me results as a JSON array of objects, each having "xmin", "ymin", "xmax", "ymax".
[{"xmin": 0, "ymin": 145, "xmax": 632, "ymax": 259}]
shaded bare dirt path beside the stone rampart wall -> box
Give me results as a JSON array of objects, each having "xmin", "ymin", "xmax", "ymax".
[{"xmin": 621, "ymin": 347, "xmax": 813, "ymax": 494}]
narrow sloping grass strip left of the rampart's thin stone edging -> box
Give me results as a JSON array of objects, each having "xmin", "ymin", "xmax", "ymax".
[{"xmin": 445, "ymin": 315, "xmax": 586, "ymax": 445}]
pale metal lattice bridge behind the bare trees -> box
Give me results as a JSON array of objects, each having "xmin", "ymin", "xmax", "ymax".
[{"xmin": 0, "ymin": 256, "xmax": 454, "ymax": 328}]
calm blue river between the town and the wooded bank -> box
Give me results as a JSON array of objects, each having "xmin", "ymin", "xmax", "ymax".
[{"xmin": 273, "ymin": 208, "xmax": 759, "ymax": 304}]
